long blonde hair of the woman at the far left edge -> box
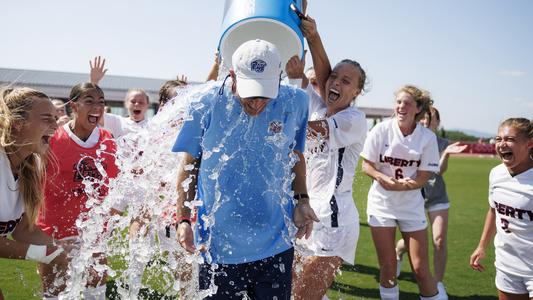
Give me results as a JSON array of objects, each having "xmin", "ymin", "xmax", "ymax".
[{"xmin": 0, "ymin": 87, "xmax": 49, "ymax": 229}]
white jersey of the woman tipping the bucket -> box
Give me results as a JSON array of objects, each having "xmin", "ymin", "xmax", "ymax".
[{"xmin": 305, "ymin": 85, "xmax": 367, "ymax": 227}]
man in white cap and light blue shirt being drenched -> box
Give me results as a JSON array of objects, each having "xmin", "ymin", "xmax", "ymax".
[{"xmin": 173, "ymin": 40, "xmax": 318, "ymax": 299}]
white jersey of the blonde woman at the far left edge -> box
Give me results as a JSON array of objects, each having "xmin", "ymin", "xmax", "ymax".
[{"xmin": 0, "ymin": 148, "xmax": 24, "ymax": 237}]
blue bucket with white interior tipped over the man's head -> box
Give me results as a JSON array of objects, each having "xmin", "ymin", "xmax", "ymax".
[{"xmin": 218, "ymin": 0, "xmax": 305, "ymax": 74}]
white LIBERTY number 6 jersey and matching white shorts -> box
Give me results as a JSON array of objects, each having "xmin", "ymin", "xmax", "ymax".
[{"xmin": 361, "ymin": 118, "xmax": 439, "ymax": 220}]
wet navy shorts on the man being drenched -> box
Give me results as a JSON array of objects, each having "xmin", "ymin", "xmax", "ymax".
[{"xmin": 200, "ymin": 248, "xmax": 294, "ymax": 300}]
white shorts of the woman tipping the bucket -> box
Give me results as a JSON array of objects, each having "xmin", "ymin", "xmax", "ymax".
[{"xmin": 297, "ymin": 222, "xmax": 359, "ymax": 265}]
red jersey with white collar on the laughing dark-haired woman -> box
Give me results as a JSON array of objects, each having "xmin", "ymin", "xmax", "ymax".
[{"xmin": 37, "ymin": 124, "xmax": 118, "ymax": 239}]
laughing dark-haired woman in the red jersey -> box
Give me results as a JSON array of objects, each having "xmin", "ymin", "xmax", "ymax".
[{"xmin": 37, "ymin": 83, "xmax": 118, "ymax": 299}]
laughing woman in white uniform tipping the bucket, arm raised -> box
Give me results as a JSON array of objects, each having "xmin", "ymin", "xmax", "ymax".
[{"xmin": 286, "ymin": 12, "xmax": 367, "ymax": 300}]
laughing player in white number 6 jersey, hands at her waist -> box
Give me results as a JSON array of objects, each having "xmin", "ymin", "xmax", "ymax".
[{"xmin": 361, "ymin": 85, "xmax": 447, "ymax": 300}]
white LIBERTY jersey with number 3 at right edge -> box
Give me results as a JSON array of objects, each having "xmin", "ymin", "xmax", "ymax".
[{"xmin": 489, "ymin": 164, "xmax": 533, "ymax": 277}]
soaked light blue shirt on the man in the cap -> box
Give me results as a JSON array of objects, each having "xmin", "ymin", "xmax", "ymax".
[{"xmin": 172, "ymin": 85, "xmax": 308, "ymax": 264}]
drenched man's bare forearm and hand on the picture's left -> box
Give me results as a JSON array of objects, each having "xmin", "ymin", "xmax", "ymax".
[{"xmin": 176, "ymin": 153, "xmax": 200, "ymax": 253}]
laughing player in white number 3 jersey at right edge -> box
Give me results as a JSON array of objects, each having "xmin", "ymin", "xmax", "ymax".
[{"xmin": 470, "ymin": 118, "xmax": 533, "ymax": 300}]
